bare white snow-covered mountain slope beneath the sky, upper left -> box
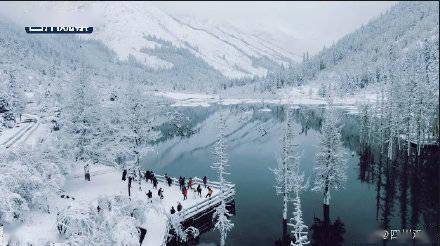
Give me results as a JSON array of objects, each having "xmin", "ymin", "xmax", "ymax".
[{"xmin": 6, "ymin": 2, "xmax": 309, "ymax": 78}]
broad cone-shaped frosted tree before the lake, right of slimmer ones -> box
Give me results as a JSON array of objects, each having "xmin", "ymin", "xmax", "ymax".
[{"xmin": 312, "ymin": 102, "xmax": 347, "ymax": 205}]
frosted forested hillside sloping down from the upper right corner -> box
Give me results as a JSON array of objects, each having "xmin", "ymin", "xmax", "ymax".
[{"xmin": 264, "ymin": 2, "xmax": 439, "ymax": 94}]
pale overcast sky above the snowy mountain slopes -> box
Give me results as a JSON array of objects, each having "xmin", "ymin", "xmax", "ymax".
[{"xmin": 0, "ymin": 1, "xmax": 395, "ymax": 49}]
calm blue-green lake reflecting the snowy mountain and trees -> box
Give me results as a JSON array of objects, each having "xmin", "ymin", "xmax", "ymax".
[{"xmin": 144, "ymin": 105, "xmax": 440, "ymax": 246}]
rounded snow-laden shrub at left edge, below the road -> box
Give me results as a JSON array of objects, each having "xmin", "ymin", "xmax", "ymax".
[{"xmin": 0, "ymin": 149, "xmax": 64, "ymax": 223}]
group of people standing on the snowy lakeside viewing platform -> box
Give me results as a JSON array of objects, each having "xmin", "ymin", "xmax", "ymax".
[{"xmin": 122, "ymin": 169, "xmax": 213, "ymax": 214}]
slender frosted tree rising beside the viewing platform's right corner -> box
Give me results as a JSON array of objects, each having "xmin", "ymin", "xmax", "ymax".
[{"xmin": 212, "ymin": 112, "xmax": 234, "ymax": 246}]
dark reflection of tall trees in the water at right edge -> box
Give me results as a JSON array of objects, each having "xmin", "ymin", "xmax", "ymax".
[{"xmin": 359, "ymin": 142, "xmax": 440, "ymax": 245}]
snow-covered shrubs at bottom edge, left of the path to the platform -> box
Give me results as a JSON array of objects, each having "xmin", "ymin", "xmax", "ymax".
[{"xmin": 57, "ymin": 196, "xmax": 147, "ymax": 245}]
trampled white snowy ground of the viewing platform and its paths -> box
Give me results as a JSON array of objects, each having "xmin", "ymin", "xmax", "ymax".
[{"xmin": 7, "ymin": 166, "xmax": 218, "ymax": 246}]
